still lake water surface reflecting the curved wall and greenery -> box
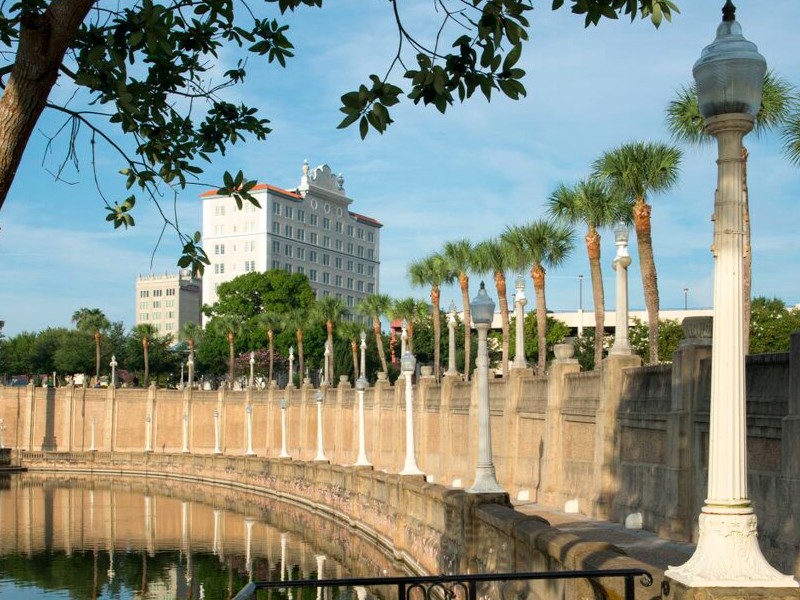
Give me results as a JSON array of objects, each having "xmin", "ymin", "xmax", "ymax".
[{"xmin": 0, "ymin": 473, "xmax": 401, "ymax": 600}]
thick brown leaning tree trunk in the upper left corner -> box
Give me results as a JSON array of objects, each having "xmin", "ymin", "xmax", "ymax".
[{"xmin": 0, "ymin": 0, "xmax": 94, "ymax": 207}]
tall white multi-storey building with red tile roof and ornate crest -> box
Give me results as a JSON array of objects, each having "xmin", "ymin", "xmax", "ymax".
[{"xmin": 201, "ymin": 162, "xmax": 383, "ymax": 316}]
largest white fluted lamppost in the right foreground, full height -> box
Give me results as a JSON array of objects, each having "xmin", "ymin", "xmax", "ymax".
[{"xmin": 666, "ymin": 0, "xmax": 798, "ymax": 587}]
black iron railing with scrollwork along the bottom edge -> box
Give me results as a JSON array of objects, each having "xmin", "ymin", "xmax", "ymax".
[{"xmin": 233, "ymin": 569, "xmax": 653, "ymax": 600}]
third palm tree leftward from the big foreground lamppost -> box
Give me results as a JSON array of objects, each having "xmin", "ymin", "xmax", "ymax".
[{"xmin": 502, "ymin": 219, "xmax": 575, "ymax": 375}]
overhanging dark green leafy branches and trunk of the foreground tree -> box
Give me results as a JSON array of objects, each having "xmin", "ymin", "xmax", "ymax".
[{"xmin": 0, "ymin": 0, "xmax": 677, "ymax": 271}]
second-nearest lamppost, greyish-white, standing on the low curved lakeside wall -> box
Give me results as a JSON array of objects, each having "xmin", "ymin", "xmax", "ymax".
[{"xmin": 467, "ymin": 281, "xmax": 505, "ymax": 494}]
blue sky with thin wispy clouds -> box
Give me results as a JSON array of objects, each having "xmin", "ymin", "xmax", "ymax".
[{"xmin": 0, "ymin": 0, "xmax": 800, "ymax": 336}]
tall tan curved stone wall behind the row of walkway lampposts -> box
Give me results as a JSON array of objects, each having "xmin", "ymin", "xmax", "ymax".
[{"xmin": 0, "ymin": 334, "xmax": 800, "ymax": 574}]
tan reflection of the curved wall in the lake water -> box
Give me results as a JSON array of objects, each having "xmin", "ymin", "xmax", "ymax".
[{"xmin": 0, "ymin": 473, "xmax": 406, "ymax": 577}]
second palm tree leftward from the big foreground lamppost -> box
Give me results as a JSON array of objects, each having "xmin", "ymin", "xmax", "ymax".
[{"xmin": 548, "ymin": 178, "xmax": 631, "ymax": 369}]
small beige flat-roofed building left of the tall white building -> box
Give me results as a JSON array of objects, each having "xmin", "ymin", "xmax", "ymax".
[{"xmin": 136, "ymin": 269, "xmax": 203, "ymax": 340}]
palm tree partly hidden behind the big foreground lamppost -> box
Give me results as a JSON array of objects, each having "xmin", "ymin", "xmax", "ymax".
[{"xmin": 667, "ymin": 71, "xmax": 800, "ymax": 348}]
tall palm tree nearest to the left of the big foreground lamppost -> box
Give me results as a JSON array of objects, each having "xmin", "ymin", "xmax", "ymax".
[{"xmin": 594, "ymin": 142, "xmax": 681, "ymax": 363}]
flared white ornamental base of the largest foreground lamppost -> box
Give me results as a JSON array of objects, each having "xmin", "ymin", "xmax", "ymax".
[{"xmin": 664, "ymin": 504, "xmax": 798, "ymax": 588}]
